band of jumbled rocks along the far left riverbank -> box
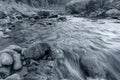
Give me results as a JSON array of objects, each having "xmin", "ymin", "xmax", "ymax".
[{"xmin": 0, "ymin": 8, "xmax": 65, "ymax": 22}]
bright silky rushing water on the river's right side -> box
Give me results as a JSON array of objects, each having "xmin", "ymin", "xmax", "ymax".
[{"xmin": 42, "ymin": 16, "xmax": 120, "ymax": 80}]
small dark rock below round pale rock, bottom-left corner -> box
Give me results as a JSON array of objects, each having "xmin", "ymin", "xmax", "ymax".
[{"xmin": 0, "ymin": 67, "xmax": 11, "ymax": 79}]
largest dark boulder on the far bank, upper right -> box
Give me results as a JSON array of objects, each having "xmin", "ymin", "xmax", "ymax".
[{"xmin": 66, "ymin": 0, "xmax": 113, "ymax": 14}]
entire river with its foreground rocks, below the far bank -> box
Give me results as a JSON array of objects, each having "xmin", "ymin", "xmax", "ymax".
[{"xmin": 0, "ymin": 12, "xmax": 120, "ymax": 80}]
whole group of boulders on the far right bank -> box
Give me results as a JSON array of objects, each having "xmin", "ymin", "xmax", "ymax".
[{"xmin": 66, "ymin": 0, "xmax": 120, "ymax": 19}]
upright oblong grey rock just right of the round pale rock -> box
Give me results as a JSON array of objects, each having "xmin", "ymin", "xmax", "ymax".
[{"xmin": 13, "ymin": 54, "xmax": 22, "ymax": 70}]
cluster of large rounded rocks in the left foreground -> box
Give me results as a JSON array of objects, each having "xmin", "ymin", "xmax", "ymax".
[{"xmin": 0, "ymin": 42, "xmax": 53, "ymax": 80}]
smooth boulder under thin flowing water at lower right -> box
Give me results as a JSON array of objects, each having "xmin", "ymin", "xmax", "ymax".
[{"xmin": 81, "ymin": 56, "xmax": 105, "ymax": 78}]
